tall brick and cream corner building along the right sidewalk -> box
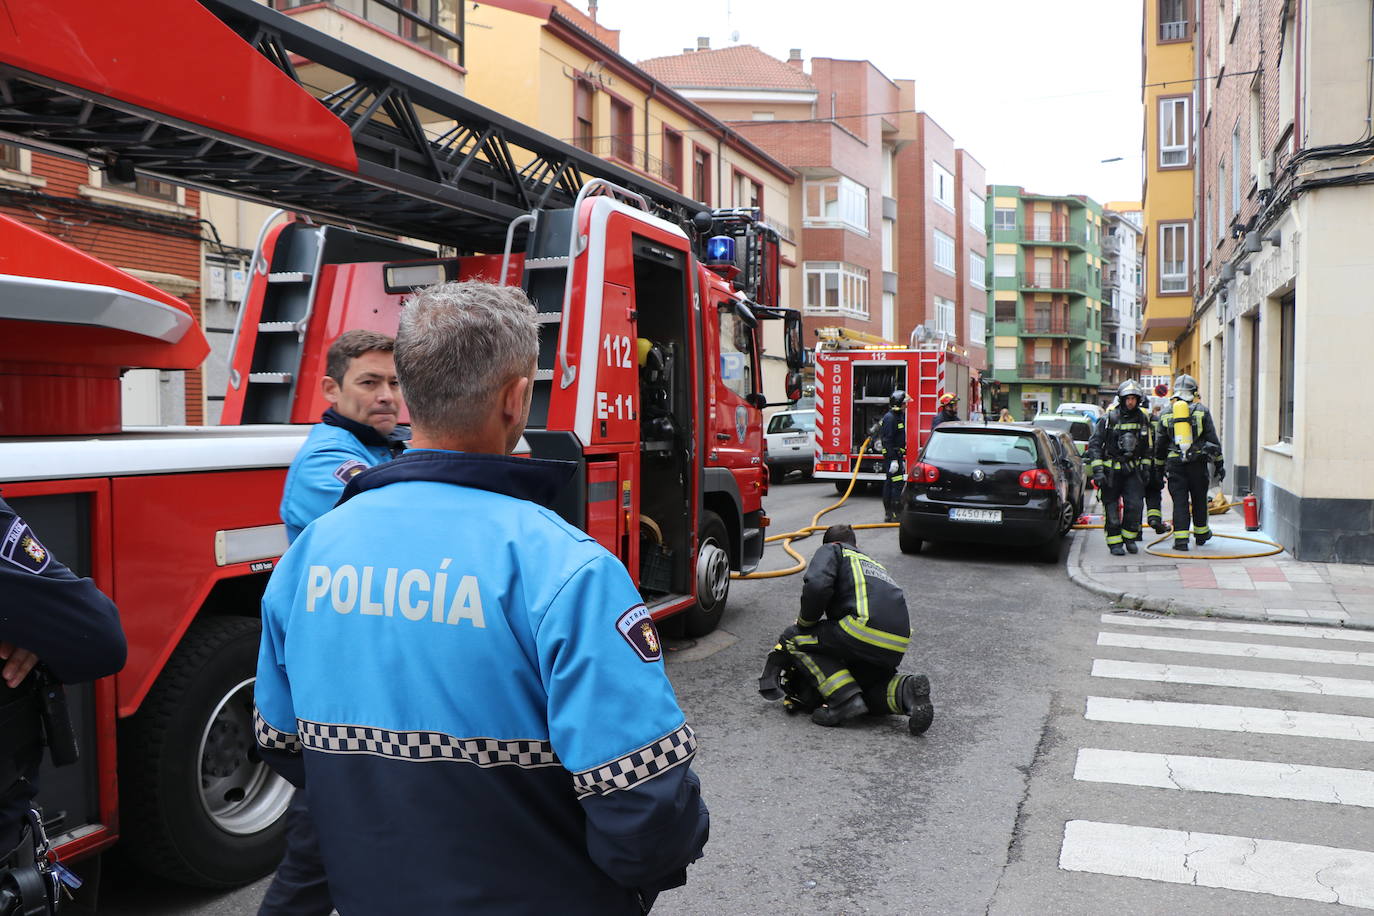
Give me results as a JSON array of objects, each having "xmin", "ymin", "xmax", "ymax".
[{"xmin": 1190, "ymin": 0, "xmax": 1374, "ymax": 563}]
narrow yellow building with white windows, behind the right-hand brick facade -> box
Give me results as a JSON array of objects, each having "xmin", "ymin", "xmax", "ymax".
[{"xmin": 1142, "ymin": 0, "xmax": 1205, "ymax": 379}]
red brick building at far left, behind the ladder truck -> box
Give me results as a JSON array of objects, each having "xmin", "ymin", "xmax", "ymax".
[{"xmin": 0, "ymin": 144, "xmax": 205, "ymax": 424}]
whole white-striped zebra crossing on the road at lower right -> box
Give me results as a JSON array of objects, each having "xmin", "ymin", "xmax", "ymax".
[{"xmin": 1059, "ymin": 614, "xmax": 1374, "ymax": 912}]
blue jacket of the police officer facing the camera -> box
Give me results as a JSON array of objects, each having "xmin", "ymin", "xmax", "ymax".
[{"xmin": 282, "ymin": 408, "xmax": 407, "ymax": 542}]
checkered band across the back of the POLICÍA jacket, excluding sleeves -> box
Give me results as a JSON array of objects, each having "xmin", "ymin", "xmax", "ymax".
[{"xmin": 297, "ymin": 718, "xmax": 559, "ymax": 769}]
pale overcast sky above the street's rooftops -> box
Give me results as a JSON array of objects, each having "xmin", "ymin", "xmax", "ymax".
[{"xmin": 572, "ymin": 0, "xmax": 1142, "ymax": 202}]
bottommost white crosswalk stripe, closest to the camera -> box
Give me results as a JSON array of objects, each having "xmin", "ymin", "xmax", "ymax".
[{"xmin": 1059, "ymin": 820, "xmax": 1374, "ymax": 909}]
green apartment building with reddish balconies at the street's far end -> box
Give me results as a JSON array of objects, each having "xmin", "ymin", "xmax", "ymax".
[{"xmin": 985, "ymin": 184, "xmax": 1103, "ymax": 419}]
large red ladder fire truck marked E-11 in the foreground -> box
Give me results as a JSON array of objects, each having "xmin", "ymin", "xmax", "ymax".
[{"xmin": 0, "ymin": 0, "xmax": 805, "ymax": 887}]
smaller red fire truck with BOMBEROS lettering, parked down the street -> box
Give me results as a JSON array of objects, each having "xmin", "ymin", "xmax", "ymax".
[{"xmin": 813, "ymin": 328, "xmax": 981, "ymax": 493}]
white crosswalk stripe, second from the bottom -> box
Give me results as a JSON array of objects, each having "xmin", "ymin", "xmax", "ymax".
[{"xmin": 1073, "ymin": 747, "xmax": 1374, "ymax": 808}]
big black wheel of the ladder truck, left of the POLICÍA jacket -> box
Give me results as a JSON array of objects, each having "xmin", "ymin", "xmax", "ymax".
[{"xmin": 120, "ymin": 617, "xmax": 294, "ymax": 887}]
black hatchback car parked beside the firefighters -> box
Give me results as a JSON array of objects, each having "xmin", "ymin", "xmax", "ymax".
[{"xmin": 897, "ymin": 423, "xmax": 1081, "ymax": 562}]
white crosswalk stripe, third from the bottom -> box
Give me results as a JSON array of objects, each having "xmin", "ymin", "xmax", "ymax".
[{"xmin": 1084, "ymin": 696, "xmax": 1374, "ymax": 742}]
